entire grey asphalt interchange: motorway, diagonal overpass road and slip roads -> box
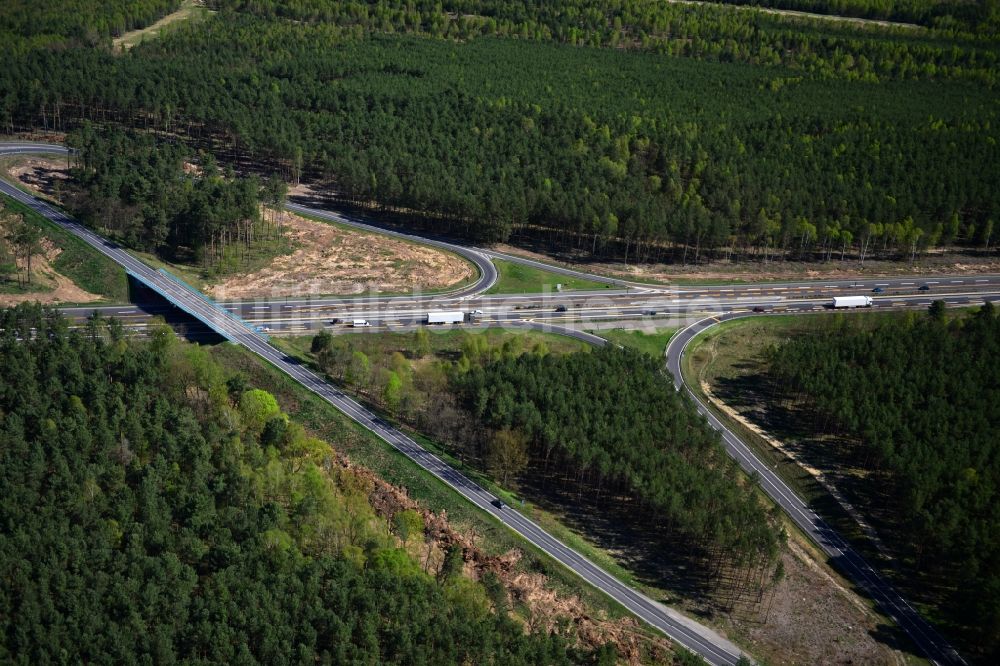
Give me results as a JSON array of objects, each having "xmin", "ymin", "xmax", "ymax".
[{"xmin": 0, "ymin": 143, "xmax": 1000, "ymax": 664}]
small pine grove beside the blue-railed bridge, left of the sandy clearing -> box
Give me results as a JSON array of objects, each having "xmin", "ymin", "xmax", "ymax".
[{"xmin": 66, "ymin": 123, "xmax": 287, "ymax": 272}]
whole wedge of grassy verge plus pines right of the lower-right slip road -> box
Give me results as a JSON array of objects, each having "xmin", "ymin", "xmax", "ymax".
[{"xmin": 688, "ymin": 307, "xmax": 1000, "ymax": 663}]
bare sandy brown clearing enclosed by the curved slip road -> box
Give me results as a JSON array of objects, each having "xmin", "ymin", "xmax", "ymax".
[{"xmin": 208, "ymin": 212, "xmax": 473, "ymax": 299}]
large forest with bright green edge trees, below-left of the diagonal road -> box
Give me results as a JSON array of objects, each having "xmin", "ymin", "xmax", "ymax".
[{"xmin": 0, "ymin": 306, "xmax": 613, "ymax": 664}]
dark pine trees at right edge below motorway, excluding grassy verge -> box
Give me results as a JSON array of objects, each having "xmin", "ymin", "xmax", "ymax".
[{"xmin": 769, "ymin": 304, "xmax": 1000, "ymax": 663}]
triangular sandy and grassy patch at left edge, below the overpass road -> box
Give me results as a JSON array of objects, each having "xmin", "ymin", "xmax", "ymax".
[{"xmin": 0, "ymin": 197, "xmax": 128, "ymax": 303}]
